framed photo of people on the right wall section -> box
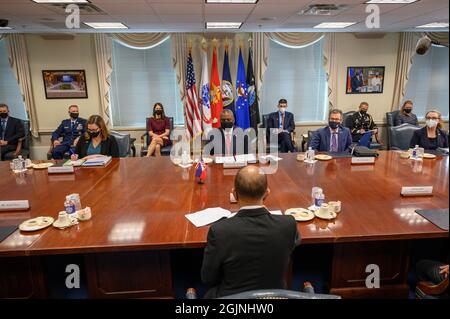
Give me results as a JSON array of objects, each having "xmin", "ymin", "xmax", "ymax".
[{"xmin": 346, "ymin": 66, "xmax": 384, "ymax": 94}]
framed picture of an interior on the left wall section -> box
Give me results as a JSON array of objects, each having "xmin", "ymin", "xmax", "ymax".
[{"xmin": 42, "ymin": 70, "xmax": 88, "ymax": 99}]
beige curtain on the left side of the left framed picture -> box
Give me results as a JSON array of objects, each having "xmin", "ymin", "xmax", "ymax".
[{"xmin": 6, "ymin": 34, "xmax": 39, "ymax": 137}]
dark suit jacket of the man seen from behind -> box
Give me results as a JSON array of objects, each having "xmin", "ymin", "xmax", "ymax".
[{"xmin": 201, "ymin": 207, "xmax": 300, "ymax": 298}]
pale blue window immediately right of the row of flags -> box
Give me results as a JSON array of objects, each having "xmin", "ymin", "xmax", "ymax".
[{"xmin": 260, "ymin": 39, "xmax": 328, "ymax": 122}]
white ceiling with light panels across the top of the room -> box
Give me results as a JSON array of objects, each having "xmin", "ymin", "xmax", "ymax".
[{"xmin": 0, "ymin": 0, "xmax": 449, "ymax": 32}]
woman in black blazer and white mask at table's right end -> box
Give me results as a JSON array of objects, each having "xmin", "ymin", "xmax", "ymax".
[{"xmin": 409, "ymin": 110, "xmax": 448, "ymax": 150}]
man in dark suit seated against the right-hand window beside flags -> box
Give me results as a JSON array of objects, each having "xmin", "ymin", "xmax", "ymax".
[{"xmin": 266, "ymin": 99, "xmax": 295, "ymax": 153}]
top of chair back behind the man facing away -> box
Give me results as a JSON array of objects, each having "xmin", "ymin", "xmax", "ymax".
[{"xmin": 219, "ymin": 289, "xmax": 341, "ymax": 299}]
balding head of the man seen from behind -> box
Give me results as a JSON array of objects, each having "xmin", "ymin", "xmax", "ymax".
[{"xmin": 234, "ymin": 166, "xmax": 267, "ymax": 201}]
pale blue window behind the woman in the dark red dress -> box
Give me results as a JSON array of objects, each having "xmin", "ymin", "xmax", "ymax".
[{"xmin": 110, "ymin": 38, "xmax": 184, "ymax": 127}]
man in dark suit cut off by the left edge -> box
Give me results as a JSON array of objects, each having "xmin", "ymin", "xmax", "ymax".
[{"xmin": 0, "ymin": 103, "xmax": 25, "ymax": 161}]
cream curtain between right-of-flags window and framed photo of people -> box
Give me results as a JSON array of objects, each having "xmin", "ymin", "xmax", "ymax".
[{"xmin": 323, "ymin": 33, "xmax": 338, "ymax": 110}]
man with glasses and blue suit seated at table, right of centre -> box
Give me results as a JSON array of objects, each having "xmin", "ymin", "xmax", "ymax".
[{"xmin": 309, "ymin": 109, "xmax": 352, "ymax": 153}]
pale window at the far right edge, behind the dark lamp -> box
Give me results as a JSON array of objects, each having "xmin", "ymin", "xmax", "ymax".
[{"xmin": 404, "ymin": 46, "xmax": 449, "ymax": 119}]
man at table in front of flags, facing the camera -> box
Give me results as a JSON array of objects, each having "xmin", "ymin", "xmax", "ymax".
[{"xmin": 208, "ymin": 109, "xmax": 248, "ymax": 156}]
